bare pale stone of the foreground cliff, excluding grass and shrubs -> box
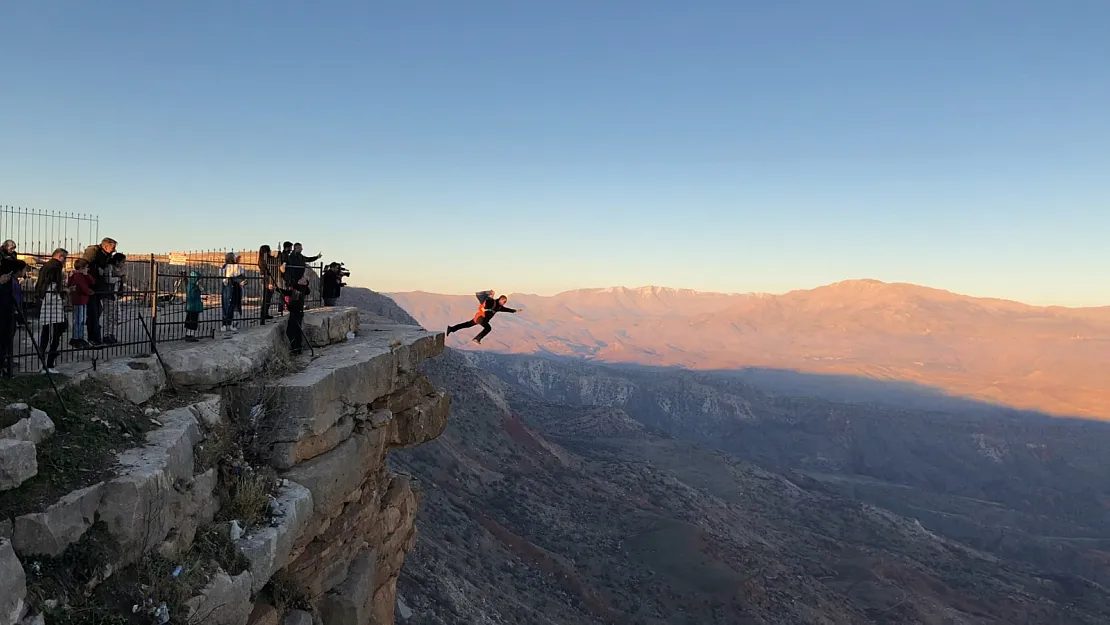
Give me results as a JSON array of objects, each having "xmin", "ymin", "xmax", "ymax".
[{"xmin": 0, "ymin": 308, "xmax": 451, "ymax": 625}]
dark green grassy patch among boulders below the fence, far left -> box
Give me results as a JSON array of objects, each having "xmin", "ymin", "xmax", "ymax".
[{"xmin": 0, "ymin": 376, "xmax": 153, "ymax": 518}]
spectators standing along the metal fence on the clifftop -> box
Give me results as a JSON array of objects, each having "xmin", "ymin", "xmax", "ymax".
[{"xmin": 0, "ymin": 238, "xmax": 341, "ymax": 376}]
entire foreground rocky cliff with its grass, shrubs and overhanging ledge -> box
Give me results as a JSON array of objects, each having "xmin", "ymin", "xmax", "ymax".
[{"xmin": 0, "ymin": 309, "xmax": 450, "ymax": 625}]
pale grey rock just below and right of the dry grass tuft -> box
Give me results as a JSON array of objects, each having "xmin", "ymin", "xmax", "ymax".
[{"xmin": 238, "ymin": 482, "xmax": 312, "ymax": 594}]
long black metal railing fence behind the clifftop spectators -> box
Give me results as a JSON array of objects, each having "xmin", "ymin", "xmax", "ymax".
[{"xmin": 0, "ymin": 245, "xmax": 324, "ymax": 374}]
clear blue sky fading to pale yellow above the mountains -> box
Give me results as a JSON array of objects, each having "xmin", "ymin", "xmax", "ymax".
[{"xmin": 0, "ymin": 0, "xmax": 1110, "ymax": 305}]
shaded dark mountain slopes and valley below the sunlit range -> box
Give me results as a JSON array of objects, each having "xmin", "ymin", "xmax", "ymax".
[{"xmin": 335, "ymin": 290, "xmax": 1110, "ymax": 625}]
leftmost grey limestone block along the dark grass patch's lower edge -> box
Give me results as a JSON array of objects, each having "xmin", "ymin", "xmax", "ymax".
[{"xmin": 12, "ymin": 482, "xmax": 104, "ymax": 557}]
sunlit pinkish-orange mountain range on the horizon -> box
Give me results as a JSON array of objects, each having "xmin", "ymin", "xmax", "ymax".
[{"xmin": 390, "ymin": 280, "xmax": 1110, "ymax": 419}]
